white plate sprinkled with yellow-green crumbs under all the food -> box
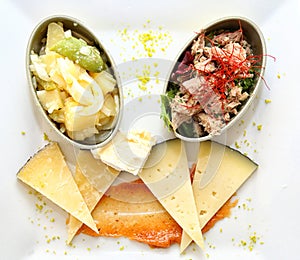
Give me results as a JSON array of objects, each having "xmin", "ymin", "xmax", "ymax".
[{"xmin": 0, "ymin": 0, "xmax": 300, "ymax": 260}]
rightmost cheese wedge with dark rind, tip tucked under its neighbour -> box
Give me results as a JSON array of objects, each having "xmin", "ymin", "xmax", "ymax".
[{"xmin": 180, "ymin": 141, "xmax": 258, "ymax": 252}]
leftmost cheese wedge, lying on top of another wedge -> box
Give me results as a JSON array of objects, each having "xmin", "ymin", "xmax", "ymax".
[{"xmin": 17, "ymin": 142, "xmax": 98, "ymax": 232}]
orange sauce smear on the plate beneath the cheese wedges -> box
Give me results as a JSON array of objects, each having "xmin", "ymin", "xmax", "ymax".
[{"xmin": 78, "ymin": 177, "xmax": 238, "ymax": 248}]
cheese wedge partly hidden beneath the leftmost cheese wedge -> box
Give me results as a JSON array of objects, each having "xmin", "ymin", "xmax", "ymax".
[{"xmin": 67, "ymin": 150, "xmax": 119, "ymax": 244}]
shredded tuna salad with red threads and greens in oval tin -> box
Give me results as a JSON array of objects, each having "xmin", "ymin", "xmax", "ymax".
[{"xmin": 162, "ymin": 28, "xmax": 260, "ymax": 138}]
